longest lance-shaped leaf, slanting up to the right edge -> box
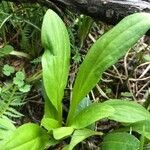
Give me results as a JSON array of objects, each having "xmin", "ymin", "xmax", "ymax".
[{"xmin": 68, "ymin": 13, "xmax": 150, "ymax": 123}]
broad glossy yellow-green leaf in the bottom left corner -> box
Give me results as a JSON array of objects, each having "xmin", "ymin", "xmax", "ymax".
[{"xmin": 4, "ymin": 123, "xmax": 49, "ymax": 150}]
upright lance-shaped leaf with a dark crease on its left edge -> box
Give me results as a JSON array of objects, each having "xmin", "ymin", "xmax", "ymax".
[{"xmin": 41, "ymin": 10, "xmax": 70, "ymax": 111}]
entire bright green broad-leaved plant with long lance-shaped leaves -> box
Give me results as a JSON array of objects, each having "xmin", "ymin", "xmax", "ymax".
[{"xmin": 0, "ymin": 10, "xmax": 150, "ymax": 150}]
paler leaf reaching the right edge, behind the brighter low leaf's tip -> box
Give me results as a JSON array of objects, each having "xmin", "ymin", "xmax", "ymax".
[{"xmin": 104, "ymin": 100, "xmax": 150, "ymax": 123}]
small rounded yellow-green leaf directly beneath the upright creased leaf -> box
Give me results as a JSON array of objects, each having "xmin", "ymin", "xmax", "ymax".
[{"xmin": 41, "ymin": 118, "xmax": 60, "ymax": 131}]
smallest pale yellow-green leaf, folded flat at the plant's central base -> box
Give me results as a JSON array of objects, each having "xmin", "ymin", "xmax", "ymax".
[{"xmin": 53, "ymin": 127, "xmax": 74, "ymax": 140}]
